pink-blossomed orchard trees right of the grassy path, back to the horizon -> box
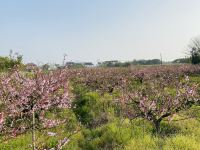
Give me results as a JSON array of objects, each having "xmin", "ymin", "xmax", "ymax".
[{"xmin": 76, "ymin": 66, "xmax": 200, "ymax": 133}]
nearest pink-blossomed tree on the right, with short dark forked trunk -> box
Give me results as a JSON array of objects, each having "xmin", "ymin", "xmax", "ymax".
[{"xmin": 121, "ymin": 75, "xmax": 200, "ymax": 133}]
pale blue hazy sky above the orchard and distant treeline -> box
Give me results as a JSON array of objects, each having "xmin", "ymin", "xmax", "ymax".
[{"xmin": 0, "ymin": 0, "xmax": 200, "ymax": 64}]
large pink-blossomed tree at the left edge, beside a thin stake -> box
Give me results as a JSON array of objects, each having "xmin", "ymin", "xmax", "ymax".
[{"xmin": 0, "ymin": 70, "xmax": 71, "ymax": 149}]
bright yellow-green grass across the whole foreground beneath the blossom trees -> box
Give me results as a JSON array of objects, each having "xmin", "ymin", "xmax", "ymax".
[{"xmin": 0, "ymin": 113, "xmax": 200, "ymax": 150}]
